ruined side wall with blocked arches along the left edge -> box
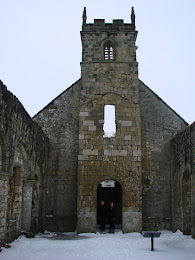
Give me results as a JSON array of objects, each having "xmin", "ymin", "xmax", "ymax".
[{"xmin": 0, "ymin": 82, "xmax": 49, "ymax": 242}]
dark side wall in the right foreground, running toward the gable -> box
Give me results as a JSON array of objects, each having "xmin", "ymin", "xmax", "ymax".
[{"xmin": 169, "ymin": 123, "xmax": 195, "ymax": 237}]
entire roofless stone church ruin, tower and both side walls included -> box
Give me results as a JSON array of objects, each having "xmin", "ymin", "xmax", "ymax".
[{"xmin": 0, "ymin": 8, "xmax": 195, "ymax": 245}]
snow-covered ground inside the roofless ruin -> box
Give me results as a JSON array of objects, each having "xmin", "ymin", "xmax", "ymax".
[{"xmin": 0, "ymin": 231, "xmax": 195, "ymax": 260}]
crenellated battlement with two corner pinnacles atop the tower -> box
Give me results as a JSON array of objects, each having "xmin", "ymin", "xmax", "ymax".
[{"xmin": 82, "ymin": 7, "xmax": 135, "ymax": 32}]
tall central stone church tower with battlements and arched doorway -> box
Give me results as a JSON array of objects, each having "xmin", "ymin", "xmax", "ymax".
[{"xmin": 77, "ymin": 9, "xmax": 142, "ymax": 232}]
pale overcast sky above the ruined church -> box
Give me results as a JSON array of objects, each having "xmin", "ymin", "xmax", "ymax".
[{"xmin": 0, "ymin": 0, "xmax": 195, "ymax": 124}]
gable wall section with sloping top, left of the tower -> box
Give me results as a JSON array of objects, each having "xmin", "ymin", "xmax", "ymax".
[{"xmin": 34, "ymin": 80, "xmax": 82, "ymax": 231}]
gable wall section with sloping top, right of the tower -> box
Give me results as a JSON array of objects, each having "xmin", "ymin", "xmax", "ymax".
[{"xmin": 139, "ymin": 81, "xmax": 187, "ymax": 230}]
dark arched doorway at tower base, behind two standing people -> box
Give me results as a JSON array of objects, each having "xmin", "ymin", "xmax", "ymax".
[{"xmin": 97, "ymin": 180, "xmax": 122, "ymax": 229}]
